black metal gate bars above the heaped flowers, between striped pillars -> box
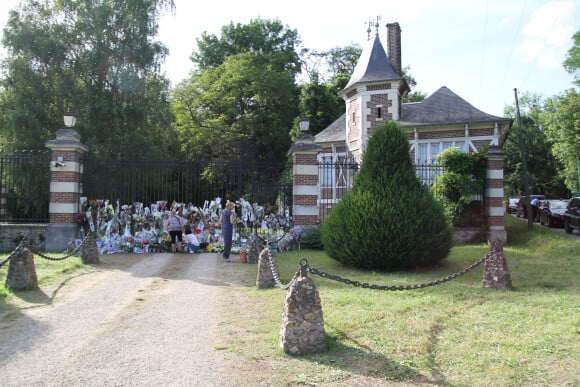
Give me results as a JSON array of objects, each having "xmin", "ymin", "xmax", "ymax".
[{"xmin": 82, "ymin": 152, "xmax": 292, "ymax": 212}]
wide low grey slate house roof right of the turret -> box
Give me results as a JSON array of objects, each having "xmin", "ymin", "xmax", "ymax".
[{"xmin": 399, "ymin": 86, "xmax": 510, "ymax": 126}]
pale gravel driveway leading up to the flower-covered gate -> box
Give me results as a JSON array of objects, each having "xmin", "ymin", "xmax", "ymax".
[{"xmin": 0, "ymin": 254, "xmax": 229, "ymax": 386}]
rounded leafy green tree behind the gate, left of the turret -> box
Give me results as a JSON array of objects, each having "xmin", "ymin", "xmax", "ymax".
[{"xmin": 173, "ymin": 19, "xmax": 300, "ymax": 161}]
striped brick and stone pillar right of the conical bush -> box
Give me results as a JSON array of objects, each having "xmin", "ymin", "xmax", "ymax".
[{"xmin": 485, "ymin": 145, "xmax": 507, "ymax": 243}]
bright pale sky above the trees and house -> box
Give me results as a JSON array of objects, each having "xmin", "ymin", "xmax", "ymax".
[{"xmin": 0, "ymin": 0, "xmax": 580, "ymax": 116}]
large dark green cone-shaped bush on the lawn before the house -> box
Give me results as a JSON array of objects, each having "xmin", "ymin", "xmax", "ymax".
[{"xmin": 321, "ymin": 122, "xmax": 451, "ymax": 271}]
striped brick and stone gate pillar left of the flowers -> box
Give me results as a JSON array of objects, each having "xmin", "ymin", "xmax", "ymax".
[{"xmin": 45, "ymin": 129, "xmax": 88, "ymax": 251}]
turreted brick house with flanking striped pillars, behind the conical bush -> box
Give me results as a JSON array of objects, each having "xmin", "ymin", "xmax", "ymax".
[{"xmin": 289, "ymin": 23, "xmax": 512, "ymax": 241}]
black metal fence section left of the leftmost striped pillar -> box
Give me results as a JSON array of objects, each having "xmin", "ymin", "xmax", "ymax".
[{"xmin": 0, "ymin": 150, "xmax": 50, "ymax": 223}]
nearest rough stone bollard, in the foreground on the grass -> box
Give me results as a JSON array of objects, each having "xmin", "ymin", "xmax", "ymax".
[{"xmin": 280, "ymin": 275, "xmax": 326, "ymax": 356}]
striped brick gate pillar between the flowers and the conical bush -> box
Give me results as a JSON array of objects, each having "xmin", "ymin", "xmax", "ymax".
[{"xmin": 288, "ymin": 134, "xmax": 320, "ymax": 228}]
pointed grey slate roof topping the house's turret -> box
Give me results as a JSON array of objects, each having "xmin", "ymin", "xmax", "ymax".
[{"xmin": 344, "ymin": 34, "xmax": 401, "ymax": 89}]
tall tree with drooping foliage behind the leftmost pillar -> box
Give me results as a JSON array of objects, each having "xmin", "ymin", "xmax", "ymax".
[{"xmin": 0, "ymin": 0, "xmax": 173, "ymax": 158}]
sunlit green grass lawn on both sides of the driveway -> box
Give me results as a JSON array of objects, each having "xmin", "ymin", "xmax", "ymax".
[{"xmin": 0, "ymin": 216, "xmax": 580, "ymax": 386}]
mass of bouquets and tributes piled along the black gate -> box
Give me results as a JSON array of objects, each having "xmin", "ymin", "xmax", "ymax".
[{"xmin": 76, "ymin": 197, "xmax": 291, "ymax": 254}]
